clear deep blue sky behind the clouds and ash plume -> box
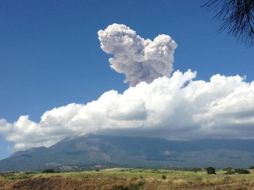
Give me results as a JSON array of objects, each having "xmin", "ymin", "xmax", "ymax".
[{"xmin": 0, "ymin": 0, "xmax": 254, "ymax": 158}]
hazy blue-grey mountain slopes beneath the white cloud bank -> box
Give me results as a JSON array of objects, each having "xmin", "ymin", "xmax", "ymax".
[{"xmin": 0, "ymin": 135, "xmax": 254, "ymax": 171}]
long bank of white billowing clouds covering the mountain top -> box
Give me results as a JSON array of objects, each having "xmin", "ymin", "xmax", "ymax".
[{"xmin": 0, "ymin": 25, "xmax": 254, "ymax": 150}]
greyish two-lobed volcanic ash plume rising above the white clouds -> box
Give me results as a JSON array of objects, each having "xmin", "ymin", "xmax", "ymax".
[{"xmin": 98, "ymin": 24, "xmax": 177, "ymax": 86}]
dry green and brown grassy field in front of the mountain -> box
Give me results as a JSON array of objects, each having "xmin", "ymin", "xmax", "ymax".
[{"xmin": 0, "ymin": 168, "xmax": 254, "ymax": 190}]
